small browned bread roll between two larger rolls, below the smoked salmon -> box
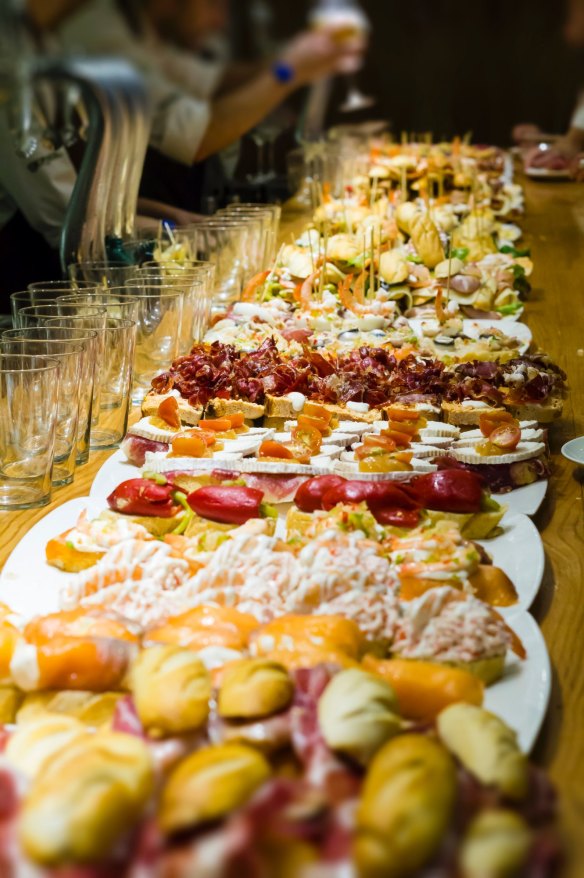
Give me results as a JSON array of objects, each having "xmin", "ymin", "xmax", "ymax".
[{"xmin": 217, "ymin": 658, "xmax": 294, "ymax": 719}]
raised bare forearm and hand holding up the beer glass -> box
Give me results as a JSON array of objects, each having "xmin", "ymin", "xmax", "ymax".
[{"xmin": 194, "ymin": 31, "xmax": 364, "ymax": 162}]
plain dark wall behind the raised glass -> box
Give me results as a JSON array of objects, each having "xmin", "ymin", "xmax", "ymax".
[{"xmin": 235, "ymin": 0, "xmax": 584, "ymax": 144}]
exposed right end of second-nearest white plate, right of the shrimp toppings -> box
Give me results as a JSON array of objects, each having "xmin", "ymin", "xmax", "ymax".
[{"xmin": 478, "ymin": 513, "xmax": 545, "ymax": 617}]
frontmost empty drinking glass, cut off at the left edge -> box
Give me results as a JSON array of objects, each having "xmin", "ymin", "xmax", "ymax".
[{"xmin": 0, "ymin": 354, "xmax": 59, "ymax": 509}]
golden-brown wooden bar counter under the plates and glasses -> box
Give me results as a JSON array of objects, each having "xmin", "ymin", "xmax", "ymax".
[{"xmin": 0, "ymin": 180, "xmax": 584, "ymax": 878}]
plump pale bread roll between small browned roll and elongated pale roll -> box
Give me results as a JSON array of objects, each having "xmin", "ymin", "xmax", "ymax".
[{"xmin": 318, "ymin": 668, "xmax": 401, "ymax": 765}]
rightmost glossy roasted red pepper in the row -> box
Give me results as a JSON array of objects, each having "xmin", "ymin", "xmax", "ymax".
[{"xmin": 409, "ymin": 469, "xmax": 484, "ymax": 513}]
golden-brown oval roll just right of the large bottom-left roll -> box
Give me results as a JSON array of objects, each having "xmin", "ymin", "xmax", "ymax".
[{"xmin": 158, "ymin": 744, "xmax": 271, "ymax": 833}]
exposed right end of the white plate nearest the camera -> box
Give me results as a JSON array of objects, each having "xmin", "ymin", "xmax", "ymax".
[{"xmin": 485, "ymin": 611, "xmax": 552, "ymax": 751}]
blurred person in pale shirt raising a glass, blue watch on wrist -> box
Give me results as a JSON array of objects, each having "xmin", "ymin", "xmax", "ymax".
[{"xmin": 55, "ymin": 0, "xmax": 365, "ymax": 210}]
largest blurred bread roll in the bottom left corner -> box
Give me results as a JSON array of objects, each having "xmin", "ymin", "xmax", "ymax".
[{"xmin": 19, "ymin": 732, "xmax": 154, "ymax": 866}]
